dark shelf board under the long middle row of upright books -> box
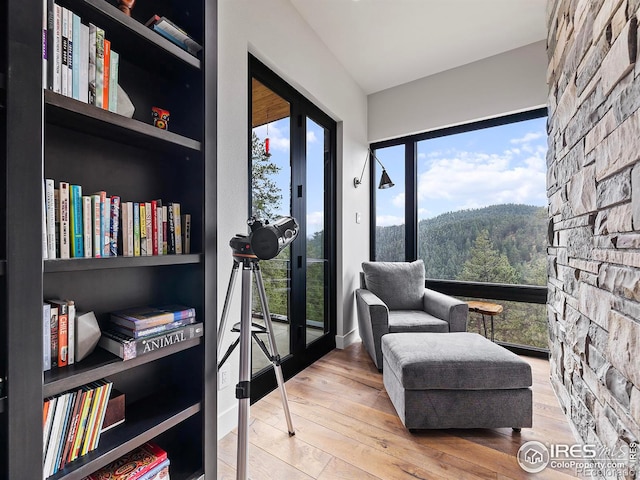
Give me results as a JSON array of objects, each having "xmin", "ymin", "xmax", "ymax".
[{"xmin": 44, "ymin": 253, "xmax": 203, "ymax": 273}]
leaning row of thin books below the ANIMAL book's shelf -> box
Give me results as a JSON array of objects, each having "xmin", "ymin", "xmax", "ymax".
[{"xmin": 42, "ymin": 379, "xmax": 113, "ymax": 478}]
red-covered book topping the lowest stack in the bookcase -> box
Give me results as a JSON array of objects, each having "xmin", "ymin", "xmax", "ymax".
[{"xmin": 86, "ymin": 442, "xmax": 167, "ymax": 480}]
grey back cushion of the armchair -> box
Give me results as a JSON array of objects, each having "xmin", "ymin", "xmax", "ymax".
[{"xmin": 362, "ymin": 260, "xmax": 424, "ymax": 310}]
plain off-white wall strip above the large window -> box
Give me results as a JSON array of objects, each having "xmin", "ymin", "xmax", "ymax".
[{"xmin": 368, "ymin": 40, "xmax": 548, "ymax": 142}]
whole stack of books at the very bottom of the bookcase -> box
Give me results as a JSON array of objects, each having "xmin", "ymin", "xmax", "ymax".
[{"xmin": 83, "ymin": 442, "xmax": 171, "ymax": 480}]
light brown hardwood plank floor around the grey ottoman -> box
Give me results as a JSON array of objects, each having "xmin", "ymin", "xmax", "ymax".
[{"xmin": 218, "ymin": 343, "xmax": 576, "ymax": 480}]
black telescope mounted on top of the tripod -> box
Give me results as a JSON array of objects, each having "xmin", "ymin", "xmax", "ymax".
[{"xmin": 229, "ymin": 217, "xmax": 300, "ymax": 260}]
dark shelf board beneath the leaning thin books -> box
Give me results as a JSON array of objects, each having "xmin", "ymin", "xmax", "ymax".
[{"xmin": 49, "ymin": 391, "xmax": 201, "ymax": 480}]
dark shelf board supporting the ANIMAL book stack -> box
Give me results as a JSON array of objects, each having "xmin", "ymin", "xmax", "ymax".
[{"xmin": 42, "ymin": 337, "xmax": 202, "ymax": 398}]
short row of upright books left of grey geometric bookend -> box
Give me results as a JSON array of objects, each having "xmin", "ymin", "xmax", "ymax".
[{"xmin": 42, "ymin": 299, "xmax": 78, "ymax": 371}]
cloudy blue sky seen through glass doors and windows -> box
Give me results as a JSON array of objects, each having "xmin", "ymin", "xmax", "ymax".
[{"xmin": 255, "ymin": 113, "xmax": 547, "ymax": 235}]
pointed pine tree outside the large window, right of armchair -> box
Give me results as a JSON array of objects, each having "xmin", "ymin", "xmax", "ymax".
[{"xmin": 458, "ymin": 230, "xmax": 518, "ymax": 283}]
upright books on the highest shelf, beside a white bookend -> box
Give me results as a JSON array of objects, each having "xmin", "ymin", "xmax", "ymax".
[{"xmin": 42, "ymin": 0, "xmax": 120, "ymax": 112}]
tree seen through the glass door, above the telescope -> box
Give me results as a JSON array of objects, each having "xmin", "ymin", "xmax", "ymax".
[{"xmin": 251, "ymin": 132, "xmax": 282, "ymax": 220}]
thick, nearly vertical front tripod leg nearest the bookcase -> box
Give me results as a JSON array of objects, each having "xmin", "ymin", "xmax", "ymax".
[{"xmin": 236, "ymin": 265, "xmax": 252, "ymax": 480}]
